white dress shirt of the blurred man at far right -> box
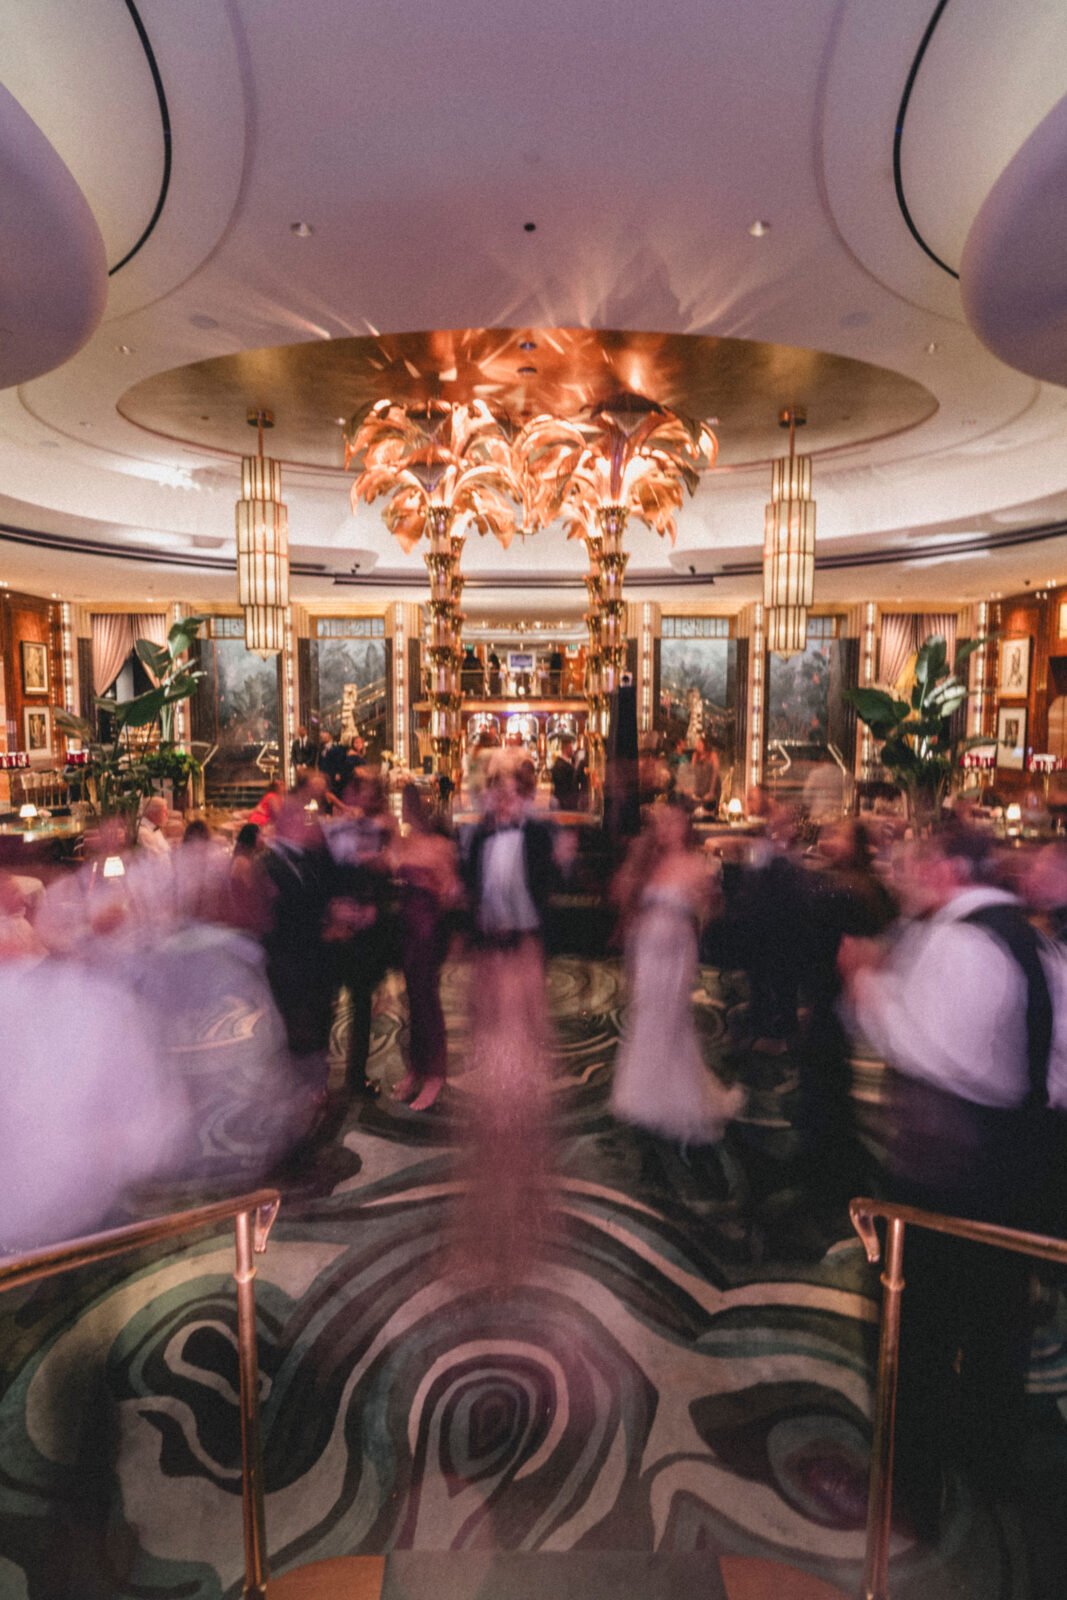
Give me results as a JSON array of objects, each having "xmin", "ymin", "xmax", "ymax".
[{"xmin": 846, "ymin": 886, "xmax": 1067, "ymax": 1109}]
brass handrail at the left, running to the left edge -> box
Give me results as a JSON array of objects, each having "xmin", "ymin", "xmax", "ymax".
[{"xmin": 0, "ymin": 1189, "xmax": 282, "ymax": 1600}]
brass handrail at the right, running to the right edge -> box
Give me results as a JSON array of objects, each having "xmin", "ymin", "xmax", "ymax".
[{"xmin": 848, "ymin": 1200, "xmax": 1067, "ymax": 1600}]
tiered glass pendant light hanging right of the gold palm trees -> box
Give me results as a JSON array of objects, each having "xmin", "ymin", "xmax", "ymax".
[{"xmin": 763, "ymin": 406, "xmax": 816, "ymax": 656}]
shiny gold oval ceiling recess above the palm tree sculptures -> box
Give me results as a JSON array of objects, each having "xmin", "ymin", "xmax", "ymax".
[{"xmin": 118, "ymin": 328, "xmax": 937, "ymax": 470}]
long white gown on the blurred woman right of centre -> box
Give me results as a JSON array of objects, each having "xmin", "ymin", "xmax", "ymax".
[{"xmin": 611, "ymin": 888, "xmax": 745, "ymax": 1144}]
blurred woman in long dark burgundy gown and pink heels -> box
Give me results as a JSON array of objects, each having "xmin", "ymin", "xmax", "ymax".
[{"xmin": 392, "ymin": 784, "xmax": 459, "ymax": 1110}]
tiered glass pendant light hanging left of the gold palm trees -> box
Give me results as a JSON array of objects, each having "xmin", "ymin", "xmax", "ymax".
[{"xmin": 237, "ymin": 411, "xmax": 290, "ymax": 661}]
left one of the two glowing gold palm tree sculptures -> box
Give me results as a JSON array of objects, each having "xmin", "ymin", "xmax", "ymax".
[{"xmin": 344, "ymin": 400, "xmax": 522, "ymax": 771}]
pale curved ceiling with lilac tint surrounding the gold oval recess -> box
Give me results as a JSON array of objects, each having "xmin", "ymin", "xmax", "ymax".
[{"xmin": 0, "ymin": 0, "xmax": 1067, "ymax": 608}]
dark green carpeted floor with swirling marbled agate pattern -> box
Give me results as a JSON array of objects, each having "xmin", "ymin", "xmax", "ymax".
[{"xmin": 0, "ymin": 958, "xmax": 1067, "ymax": 1600}]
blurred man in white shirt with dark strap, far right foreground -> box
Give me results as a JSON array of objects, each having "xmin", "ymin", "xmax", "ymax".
[{"xmin": 840, "ymin": 827, "xmax": 1067, "ymax": 1536}]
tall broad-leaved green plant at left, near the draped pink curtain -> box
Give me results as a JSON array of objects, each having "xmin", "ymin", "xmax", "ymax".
[{"xmin": 53, "ymin": 616, "xmax": 206, "ymax": 840}]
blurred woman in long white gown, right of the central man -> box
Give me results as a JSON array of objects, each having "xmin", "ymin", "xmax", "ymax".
[{"xmin": 611, "ymin": 803, "xmax": 745, "ymax": 1144}]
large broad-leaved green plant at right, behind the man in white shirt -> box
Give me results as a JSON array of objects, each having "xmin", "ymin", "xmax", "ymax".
[{"xmin": 843, "ymin": 634, "xmax": 989, "ymax": 827}]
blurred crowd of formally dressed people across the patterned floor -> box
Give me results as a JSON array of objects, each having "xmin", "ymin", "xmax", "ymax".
[{"xmin": 0, "ymin": 742, "xmax": 1067, "ymax": 1529}]
